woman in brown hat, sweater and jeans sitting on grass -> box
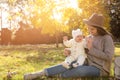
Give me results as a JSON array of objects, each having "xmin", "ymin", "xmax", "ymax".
[{"xmin": 24, "ymin": 13, "xmax": 114, "ymax": 80}]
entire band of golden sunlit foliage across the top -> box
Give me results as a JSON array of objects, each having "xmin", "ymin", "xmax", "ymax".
[{"xmin": 0, "ymin": 0, "xmax": 110, "ymax": 35}]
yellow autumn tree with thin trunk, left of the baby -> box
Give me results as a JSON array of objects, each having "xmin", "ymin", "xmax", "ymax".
[{"xmin": 28, "ymin": 0, "xmax": 69, "ymax": 47}]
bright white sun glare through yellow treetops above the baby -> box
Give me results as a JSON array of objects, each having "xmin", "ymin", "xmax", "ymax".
[{"xmin": 53, "ymin": 0, "xmax": 82, "ymax": 21}]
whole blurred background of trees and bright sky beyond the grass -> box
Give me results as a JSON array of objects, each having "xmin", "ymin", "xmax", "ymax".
[{"xmin": 0, "ymin": 0, "xmax": 120, "ymax": 47}]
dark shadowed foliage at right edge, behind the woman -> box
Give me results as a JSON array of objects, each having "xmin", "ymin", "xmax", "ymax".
[{"xmin": 108, "ymin": 0, "xmax": 120, "ymax": 42}]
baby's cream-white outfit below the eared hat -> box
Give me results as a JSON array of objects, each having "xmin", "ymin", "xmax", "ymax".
[{"xmin": 63, "ymin": 39, "xmax": 87, "ymax": 65}]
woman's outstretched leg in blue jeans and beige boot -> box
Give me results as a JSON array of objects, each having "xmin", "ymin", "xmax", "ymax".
[{"xmin": 24, "ymin": 65, "xmax": 68, "ymax": 80}]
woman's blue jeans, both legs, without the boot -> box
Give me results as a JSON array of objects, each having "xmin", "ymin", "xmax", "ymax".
[{"xmin": 45, "ymin": 65, "xmax": 100, "ymax": 78}]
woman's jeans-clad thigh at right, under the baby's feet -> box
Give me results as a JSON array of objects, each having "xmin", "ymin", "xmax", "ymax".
[{"xmin": 61, "ymin": 66, "xmax": 100, "ymax": 78}]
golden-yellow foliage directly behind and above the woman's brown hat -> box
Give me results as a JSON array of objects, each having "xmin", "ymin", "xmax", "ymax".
[{"xmin": 78, "ymin": 0, "xmax": 110, "ymax": 35}]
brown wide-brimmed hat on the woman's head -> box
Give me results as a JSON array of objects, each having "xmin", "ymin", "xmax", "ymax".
[{"xmin": 83, "ymin": 13, "xmax": 104, "ymax": 28}]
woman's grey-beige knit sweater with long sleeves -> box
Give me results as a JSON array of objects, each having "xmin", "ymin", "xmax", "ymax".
[{"xmin": 87, "ymin": 35, "xmax": 114, "ymax": 76}]
